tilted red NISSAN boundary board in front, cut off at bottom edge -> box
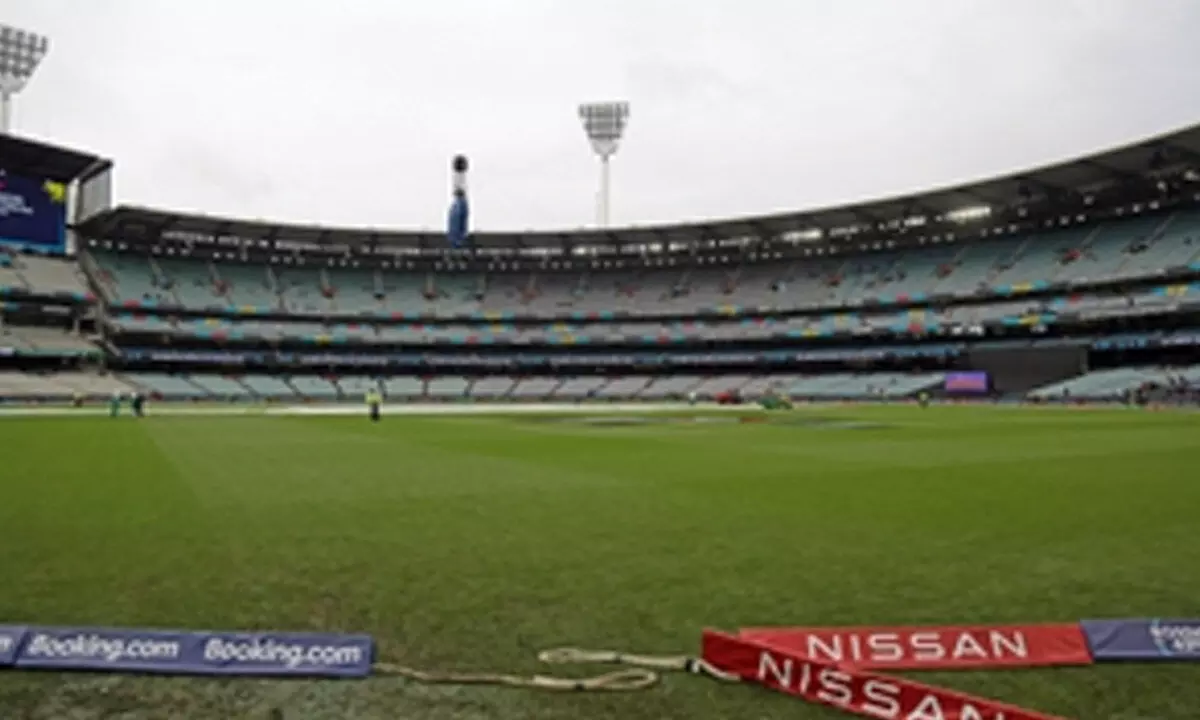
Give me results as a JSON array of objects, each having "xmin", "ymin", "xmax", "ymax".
[{"xmin": 703, "ymin": 631, "xmax": 1062, "ymax": 720}]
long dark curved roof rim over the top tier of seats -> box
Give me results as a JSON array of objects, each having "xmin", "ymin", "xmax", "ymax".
[{"xmin": 79, "ymin": 125, "xmax": 1200, "ymax": 248}]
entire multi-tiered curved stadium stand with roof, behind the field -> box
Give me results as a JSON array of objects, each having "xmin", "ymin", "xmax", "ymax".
[{"xmin": 0, "ymin": 126, "xmax": 1200, "ymax": 401}]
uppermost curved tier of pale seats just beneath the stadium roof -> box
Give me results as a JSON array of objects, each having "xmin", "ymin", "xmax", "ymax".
[{"xmin": 88, "ymin": 211, "xmax": 1200, "ymax": 314}]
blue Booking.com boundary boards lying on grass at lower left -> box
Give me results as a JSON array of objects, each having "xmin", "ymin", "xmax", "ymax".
[{"xmin": 0, "ymin": 625, "xmax": 374, "ymax": 678}]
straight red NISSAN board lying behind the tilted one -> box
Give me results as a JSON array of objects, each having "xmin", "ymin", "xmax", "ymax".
[{"xmin": 738, "ymin": 623, "xmax": 1092, "ymax": 670}]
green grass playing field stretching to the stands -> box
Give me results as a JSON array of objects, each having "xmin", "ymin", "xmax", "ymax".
[{"xmin": 0, "ymin": 407, "xmax": 1200, "ymax": 720}]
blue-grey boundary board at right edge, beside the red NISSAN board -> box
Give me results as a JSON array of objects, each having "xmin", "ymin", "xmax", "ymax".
[{"xmin": 1082, "ymin": 618, "xmax": 1200, "ymax": 662}]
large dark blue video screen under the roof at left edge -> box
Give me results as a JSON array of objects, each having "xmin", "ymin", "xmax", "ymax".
[{"xmin": 0, "ymin": 168, "xmax": 67, "ymax": 252}]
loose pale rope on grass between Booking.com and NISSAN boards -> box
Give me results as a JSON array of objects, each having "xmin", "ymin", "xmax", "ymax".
[{"xmin": 374, "ymin": 648, "xmax": 739, "ymax": 692}]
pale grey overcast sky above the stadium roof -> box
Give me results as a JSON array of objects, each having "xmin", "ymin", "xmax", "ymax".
[{"xmin": 7, "ymin": 0, "xmax": 1200, "ymax": 229}]
